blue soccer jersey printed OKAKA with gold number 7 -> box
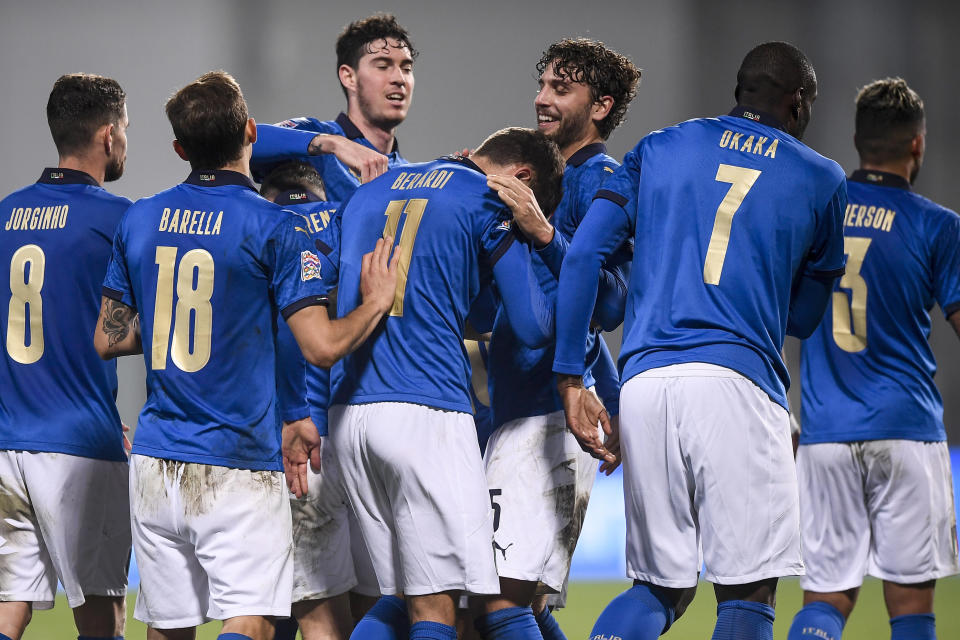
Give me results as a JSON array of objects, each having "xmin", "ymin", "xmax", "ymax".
[{"xmin": 554, "ymin": 108, "xmax": 847, "ymax": 407}]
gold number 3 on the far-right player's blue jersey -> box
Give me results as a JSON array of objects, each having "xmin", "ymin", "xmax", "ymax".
[{"xmin": 833, "ymin": 238, "xmax": 872, "ymax": 353}]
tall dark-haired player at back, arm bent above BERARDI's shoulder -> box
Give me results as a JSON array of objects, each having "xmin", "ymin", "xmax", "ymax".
[{"xmin": 253, "ymin": 13, "xmax": 417, "ymax": 202}]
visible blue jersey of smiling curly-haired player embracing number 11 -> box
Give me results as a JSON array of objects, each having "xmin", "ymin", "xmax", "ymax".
[{"xmin": 490, "ymin": 143, "xmax": 626, "ymax": 427}]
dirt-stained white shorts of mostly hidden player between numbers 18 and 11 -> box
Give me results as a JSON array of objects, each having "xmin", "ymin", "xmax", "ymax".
[{"xmin": 290, "ymin": 438, "xmax": 357, "ymax": 602}]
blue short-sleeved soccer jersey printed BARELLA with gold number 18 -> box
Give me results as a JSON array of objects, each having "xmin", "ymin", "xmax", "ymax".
[{"xmin": 103, "ymin": 171, "xmax": 326, "ymax": 470}]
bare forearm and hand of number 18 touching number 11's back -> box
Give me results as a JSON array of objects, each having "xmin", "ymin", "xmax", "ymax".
[{"xmin": 287, "ymin": 237, "xmax": 400, "ymax": 368}]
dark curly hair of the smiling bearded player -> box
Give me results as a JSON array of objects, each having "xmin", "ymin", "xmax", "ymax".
[{"xmin": 537, "ymin": 38, "xmax": 641, "ymax": 140}]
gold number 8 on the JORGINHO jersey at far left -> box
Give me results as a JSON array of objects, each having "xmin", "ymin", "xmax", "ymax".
[{"xmin": 7, "ymin": 244, "xmax": 47, "ymax": 364}]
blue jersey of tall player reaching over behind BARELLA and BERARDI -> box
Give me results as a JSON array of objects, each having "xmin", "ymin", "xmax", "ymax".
[{"xmin": 250, "ymin": 113, "xmax": 407, "ymax": 202}]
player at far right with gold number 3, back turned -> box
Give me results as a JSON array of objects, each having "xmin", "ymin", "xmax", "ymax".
[{"xmin": 788, "ymin": 78, "xmax": 960, "ymax": 640}]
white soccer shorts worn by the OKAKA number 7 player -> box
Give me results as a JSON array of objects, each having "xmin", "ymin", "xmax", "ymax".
[{"xmin": 620, "ymin": 363, "xmax": 803, "ymax": 588}]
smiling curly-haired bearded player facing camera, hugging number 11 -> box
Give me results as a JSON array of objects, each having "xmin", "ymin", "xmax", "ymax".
[{"xmin": 484, "ymin": 38, "xmax": 640, "ymax": 638}]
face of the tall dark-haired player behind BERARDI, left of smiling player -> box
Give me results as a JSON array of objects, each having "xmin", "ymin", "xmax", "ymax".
[{"xmin": 355, "ymin": 39, "xmax": 413, "ymax": 130}]
